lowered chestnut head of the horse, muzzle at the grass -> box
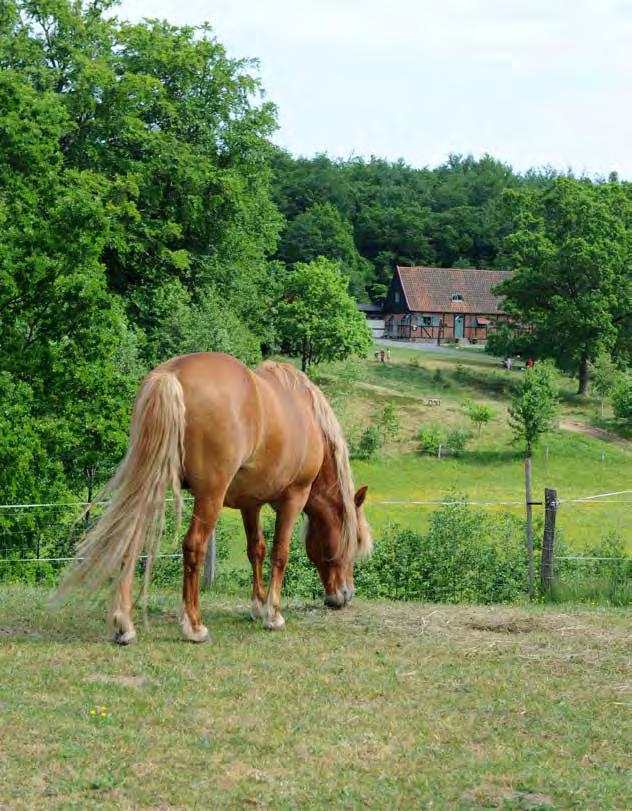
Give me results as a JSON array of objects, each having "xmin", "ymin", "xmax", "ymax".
[{"xmin": 305, "ymin": 486, "xmax": 373, "ymax": 608}]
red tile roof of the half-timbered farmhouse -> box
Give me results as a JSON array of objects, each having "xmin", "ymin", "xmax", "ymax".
[{"xmin": 395, "ymin": 266, "xmax": 513, "ymax": 315}]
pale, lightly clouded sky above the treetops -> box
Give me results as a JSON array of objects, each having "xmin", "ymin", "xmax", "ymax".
[{"xmin": 118, "ymin": 0, "xmax": 632, "ymax": 179}]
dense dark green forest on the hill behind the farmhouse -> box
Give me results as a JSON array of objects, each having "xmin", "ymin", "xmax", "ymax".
[{"xmin": 273, "ymin": 152, "xmax": 550, "ymax": 300}]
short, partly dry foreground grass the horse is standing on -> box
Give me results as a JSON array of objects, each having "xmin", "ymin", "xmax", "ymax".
[{"xmin": 0, "ymin": 587, "xmax": 632, "ymax": 809}]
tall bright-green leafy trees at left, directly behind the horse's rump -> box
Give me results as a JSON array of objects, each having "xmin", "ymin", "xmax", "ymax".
[{"xmin": 0, "ymin": 0, "xmax": 280, "ymax": 552}]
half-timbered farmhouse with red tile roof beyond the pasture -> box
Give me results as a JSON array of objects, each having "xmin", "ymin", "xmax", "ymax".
[{"xmin": 384, "ymin": 266, "xmax": 513, "ymax": 343}]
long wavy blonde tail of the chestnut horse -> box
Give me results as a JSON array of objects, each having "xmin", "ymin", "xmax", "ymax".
[{"xmin": 61, "ymin": 371, "xmax": 185, "ymax": 603}]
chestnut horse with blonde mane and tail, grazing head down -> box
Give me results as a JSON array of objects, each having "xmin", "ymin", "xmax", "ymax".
[{"xmin": 64, "ymin": 353, "xmax": 372, "ymax": 644}]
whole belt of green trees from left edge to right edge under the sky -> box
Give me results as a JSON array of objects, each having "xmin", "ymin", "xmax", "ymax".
[{"xmin": 0, "ymin": 0, "xmax": 632, "ymax": 552}]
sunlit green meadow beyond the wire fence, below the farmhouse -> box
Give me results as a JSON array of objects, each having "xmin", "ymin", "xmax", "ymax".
[{"xmin": 318, "ymin": 349, "xmax": 632, "ymax": 550}]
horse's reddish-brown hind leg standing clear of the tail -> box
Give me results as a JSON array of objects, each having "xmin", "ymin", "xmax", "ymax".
[{"xmin": 180, "ymin": 498, "xmax": 222, "ymax": 642}]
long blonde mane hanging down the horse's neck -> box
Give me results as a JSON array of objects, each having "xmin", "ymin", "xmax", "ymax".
[{"xmin": 259, "ymin": 361, "xmax": 368, "ymax": 558}]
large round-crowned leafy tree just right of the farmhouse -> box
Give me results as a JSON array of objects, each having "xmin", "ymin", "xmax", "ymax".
[{"xmin": 499, "ymin": 178, "xmax": 632, "ymax": 393}]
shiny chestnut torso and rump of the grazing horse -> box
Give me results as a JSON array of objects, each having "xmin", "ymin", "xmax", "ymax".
[{"xmin": 159, "ymin": 352, "xmax": 323, "ymax": 507}]
